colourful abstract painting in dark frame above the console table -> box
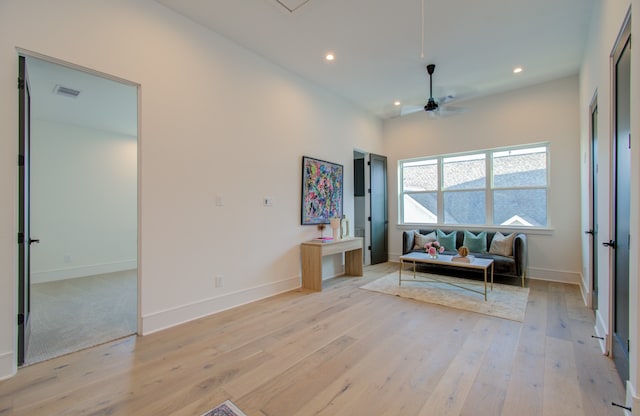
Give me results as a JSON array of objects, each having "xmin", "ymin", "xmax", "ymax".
[{"xmin": 302, "ymin": 156, "xmax": 344, "ymax": 225}]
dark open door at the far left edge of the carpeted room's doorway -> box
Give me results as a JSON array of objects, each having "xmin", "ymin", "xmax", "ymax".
[{"xmin": 18, "ymin": 56, "xmax": 37, "ymax": 365}]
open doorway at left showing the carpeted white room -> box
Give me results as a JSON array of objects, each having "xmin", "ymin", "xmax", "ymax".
[{"xmin": 18, "ymin": 54, "xmax": 138, "ymax": 365}]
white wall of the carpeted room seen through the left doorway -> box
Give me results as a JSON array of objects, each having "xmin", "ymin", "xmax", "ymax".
[{"xmin": 31, "ymin": 120, "xmax": 138, "ymax": 283}]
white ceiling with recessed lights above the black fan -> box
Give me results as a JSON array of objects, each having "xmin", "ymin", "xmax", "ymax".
[{"xmin": 156, "ymin": 0, "xmax": 595, "ymax": 118}]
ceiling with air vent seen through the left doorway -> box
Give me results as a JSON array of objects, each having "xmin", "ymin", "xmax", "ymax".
[{"xmin": 27, "ymin": 57, "xmax": 138, "ymax": 136}]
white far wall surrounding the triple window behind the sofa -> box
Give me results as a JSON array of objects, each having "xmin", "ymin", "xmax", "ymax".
[{"xmin": 384, "ymin": 76, "xmax": 582, "ymax": 283}]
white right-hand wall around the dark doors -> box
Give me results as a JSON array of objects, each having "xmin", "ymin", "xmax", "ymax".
[{"xmin": 580, "ymin": 0, "xmax": 640, "ymax": 409}]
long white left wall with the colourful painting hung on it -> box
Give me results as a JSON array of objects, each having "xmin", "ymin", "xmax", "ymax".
[{"xmin": 0, "ymin": 0, "xmax": 382, "ymax": 378}]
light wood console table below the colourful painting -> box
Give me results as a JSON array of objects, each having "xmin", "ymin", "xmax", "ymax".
[{"xmin": 300, "ymin": 237, "xmax": 363, "ymax": 291}]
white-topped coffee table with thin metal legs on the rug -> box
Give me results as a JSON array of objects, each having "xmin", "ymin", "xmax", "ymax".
[{"xmin": 398, "ymin": 252, "xmax": 493, "ymax": 302}]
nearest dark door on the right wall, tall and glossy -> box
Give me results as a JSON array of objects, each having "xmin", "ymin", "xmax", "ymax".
[{"xmin": 612, "ymin": 26, "xmax": 631, "ymax": 381}]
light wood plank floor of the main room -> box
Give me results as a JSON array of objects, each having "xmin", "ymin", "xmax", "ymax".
[{"xmin": 0, "ymin": 263, "xmax": 624, "ymax": 416}]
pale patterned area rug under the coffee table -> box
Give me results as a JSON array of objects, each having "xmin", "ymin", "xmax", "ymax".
[{"xmin": 361, "ymin": 272, "xmax": 529, "ymax": 322}]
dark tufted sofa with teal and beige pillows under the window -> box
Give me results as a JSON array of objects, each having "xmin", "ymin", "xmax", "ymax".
[{"xmin": 402, "ymin": 229, "xmax": 527, "ymax": 287}]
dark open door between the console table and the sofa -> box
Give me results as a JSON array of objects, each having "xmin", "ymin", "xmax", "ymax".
[{"xmin": 369, "ymin": 154, "xmax": 389, "ymax": 264}]
